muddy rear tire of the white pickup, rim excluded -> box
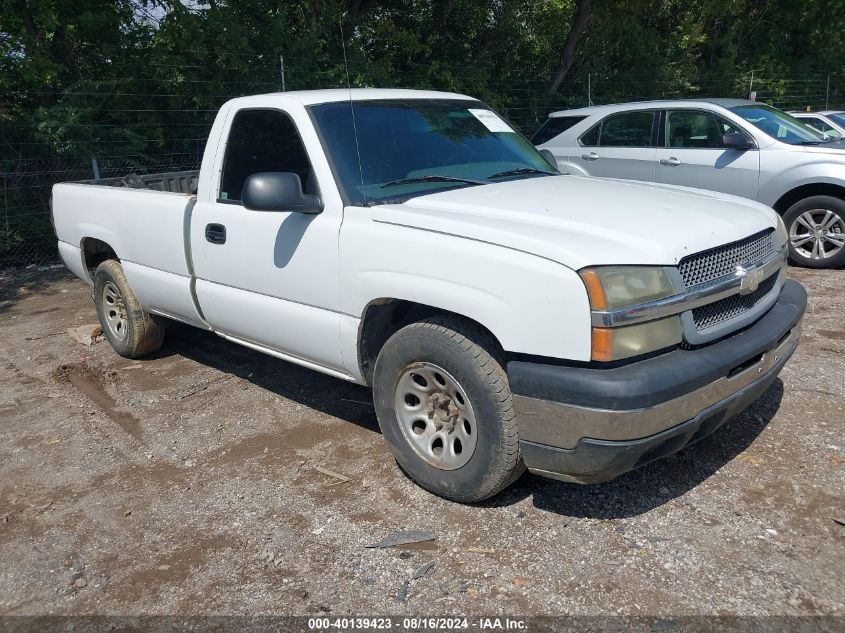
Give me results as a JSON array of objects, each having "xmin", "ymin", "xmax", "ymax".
[{"xmin": 94, "ymin": 259, "xmax": 165, "ymax": 358}]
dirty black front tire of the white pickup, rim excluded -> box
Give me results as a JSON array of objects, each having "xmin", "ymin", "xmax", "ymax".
[{"xmin": 373, "ymin": 316, "xmax": 525, "ymax": 503}]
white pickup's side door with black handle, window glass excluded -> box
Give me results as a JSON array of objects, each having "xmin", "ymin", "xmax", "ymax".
[{"xmin": 191, "ymin": 108, "xmax": 347, "ymax": 374}]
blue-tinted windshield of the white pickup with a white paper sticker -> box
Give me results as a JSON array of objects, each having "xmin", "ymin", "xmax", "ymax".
[{"xmin": 310, "ymin": 99, "xmax": 557, "ymax": 205}]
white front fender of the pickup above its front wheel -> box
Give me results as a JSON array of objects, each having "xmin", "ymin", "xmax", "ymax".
[{"xmin": 340, "ymin": 216, "xmax": 591, "ymax": 361}]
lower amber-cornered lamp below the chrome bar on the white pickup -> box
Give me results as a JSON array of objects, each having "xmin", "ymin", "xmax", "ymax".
[{"xmin": 592, "ymin": 316, "xmax": 683, "ymax": 362}]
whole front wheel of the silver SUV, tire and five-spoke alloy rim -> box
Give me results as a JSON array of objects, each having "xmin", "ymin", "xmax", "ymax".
[{"xmin": 783, "ymin": 196, "xmax": 845, "ymax": 268}]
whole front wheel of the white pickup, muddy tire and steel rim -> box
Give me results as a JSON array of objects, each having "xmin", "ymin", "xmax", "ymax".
[{"xmin": 373, "ymin": 317, "xmax": 525, "ymax": 503}]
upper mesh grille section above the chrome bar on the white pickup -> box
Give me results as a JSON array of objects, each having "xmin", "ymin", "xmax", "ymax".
[{"xmin": 678, "ymin": 229, "xmax": 775, "ymax": 288}]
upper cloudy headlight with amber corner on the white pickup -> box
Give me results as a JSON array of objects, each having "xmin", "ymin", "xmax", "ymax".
[{"xmin": 579, "ymin": 266, "xmax": 675, "ymax": 310}]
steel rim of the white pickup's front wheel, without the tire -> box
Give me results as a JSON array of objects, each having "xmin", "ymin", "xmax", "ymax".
[{"xmin": 394, "ymin": 363, "xmax": 478, "ymax": 470}]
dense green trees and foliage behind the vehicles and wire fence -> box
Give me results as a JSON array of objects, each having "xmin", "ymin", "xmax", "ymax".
[{"xmin": 0, "ymin": 0, "xmax": 845, "ymax": 263}]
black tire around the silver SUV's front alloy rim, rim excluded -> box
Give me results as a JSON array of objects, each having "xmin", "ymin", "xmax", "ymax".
[{"xmin": 783, "ymin": 196, "xmax": 845, "ymax": 268}]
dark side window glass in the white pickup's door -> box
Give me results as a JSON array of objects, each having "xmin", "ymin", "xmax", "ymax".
[{"xmin": 218, "ymin": 110, "xmax": 316, "ymax": 202}]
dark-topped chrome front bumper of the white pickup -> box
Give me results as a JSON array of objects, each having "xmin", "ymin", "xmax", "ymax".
[{"xmin": 508, "ymin": 281, "xmax": 807, "ymax": 483}]
